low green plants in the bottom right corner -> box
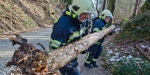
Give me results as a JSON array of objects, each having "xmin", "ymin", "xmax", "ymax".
[{"xmin": 112, "ymin": 58, "xmax": 150, "ymax": 75}]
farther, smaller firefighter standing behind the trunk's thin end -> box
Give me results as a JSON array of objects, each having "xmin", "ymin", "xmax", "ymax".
[{"xmin": 84, "ymin": 9, "xmax": 113, "ymax": 68}]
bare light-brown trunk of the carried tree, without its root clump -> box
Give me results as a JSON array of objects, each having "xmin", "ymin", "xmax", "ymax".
[{"xmin": 47, "ymin": 25, "xmax": 115, "ymax": 70}]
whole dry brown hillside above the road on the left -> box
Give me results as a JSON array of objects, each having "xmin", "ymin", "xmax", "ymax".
[{"xmin": 0, "ymin": 0, "xmax": 65, "ymax": 37}]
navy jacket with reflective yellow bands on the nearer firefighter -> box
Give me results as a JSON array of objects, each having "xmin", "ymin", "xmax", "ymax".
[{"xmin": 50, "ymin": 11, "xmax": 85, "ymax": 49}]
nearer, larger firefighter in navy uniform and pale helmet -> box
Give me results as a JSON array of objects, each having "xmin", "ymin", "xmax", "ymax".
[{"xmin": 49, "ymin": 0, "xmax": 95, "ymax": 75}]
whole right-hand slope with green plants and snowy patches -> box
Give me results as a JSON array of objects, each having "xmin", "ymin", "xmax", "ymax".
[{"xmin": 101, "ymin": 0, "xmax": 150, "ymax": 75}]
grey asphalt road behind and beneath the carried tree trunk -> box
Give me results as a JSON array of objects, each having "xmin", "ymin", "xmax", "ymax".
[{"xmin": 0, "ymin": 28, "xmax": 110, "ymax": 75}]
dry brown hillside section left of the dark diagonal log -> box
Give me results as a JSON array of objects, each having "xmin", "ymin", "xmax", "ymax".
[{"xmin": 0, "ymin": 0, "xmax": 37, "ymax": 35}]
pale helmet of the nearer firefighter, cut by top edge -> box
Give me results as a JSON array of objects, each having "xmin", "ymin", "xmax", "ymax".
[{"xmin": 69, "ymin": 0, "xmax": 95, "ymax": 15}]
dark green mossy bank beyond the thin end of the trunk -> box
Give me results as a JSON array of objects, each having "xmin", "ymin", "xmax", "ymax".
[{"xmin": 115, "ymin": 11, "xmax": 150, "ymax": 43}]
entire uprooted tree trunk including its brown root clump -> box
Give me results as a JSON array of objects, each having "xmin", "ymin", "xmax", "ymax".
[{"xmin": 6, "ymin": 25, "xmax": 115, "ymax": 75}]
